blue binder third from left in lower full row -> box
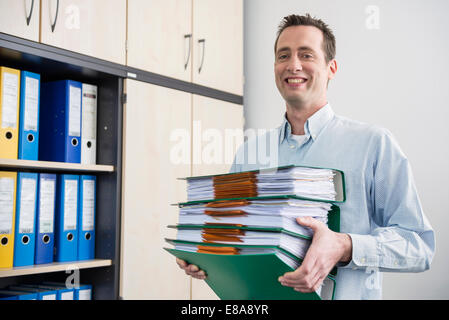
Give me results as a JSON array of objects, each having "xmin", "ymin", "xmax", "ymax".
[{"xmin": 34, "ymin": 173, "xmax": 56, "ymax": 264}]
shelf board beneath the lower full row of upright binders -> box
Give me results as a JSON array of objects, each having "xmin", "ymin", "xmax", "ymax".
[{"xmin": 0, "ymin": 259, "xmax": 112, "ymax": 278}]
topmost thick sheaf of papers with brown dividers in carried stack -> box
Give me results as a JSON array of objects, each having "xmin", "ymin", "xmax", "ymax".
[{"xmin": 187, "ymin": 166, "xmax": 337, "ymax": 201}]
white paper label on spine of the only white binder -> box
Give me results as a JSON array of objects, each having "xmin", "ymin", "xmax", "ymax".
[{"xmin": 82, "ymin": 85, "xmax": 97, "ymax": 140}]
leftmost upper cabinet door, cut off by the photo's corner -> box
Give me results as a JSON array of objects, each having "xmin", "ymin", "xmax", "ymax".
[{"xmin": 0, "ymin": 0, "xmax": 40, "ymax": 42}]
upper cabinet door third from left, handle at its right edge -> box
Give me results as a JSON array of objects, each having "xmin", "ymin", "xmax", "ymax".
[{"xmin": 127, "ymin": 0, "xmax": 192, "ymax": 82}]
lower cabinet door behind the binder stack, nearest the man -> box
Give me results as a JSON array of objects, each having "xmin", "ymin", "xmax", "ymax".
[{"xmin": 192, "ymin": 95, "xmax": 244, "ymax": 300}]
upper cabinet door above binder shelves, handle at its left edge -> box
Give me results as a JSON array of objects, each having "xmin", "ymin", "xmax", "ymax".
[{"xmin": 41, "ymin": 0, "xmax": 126, "ymax": 64}]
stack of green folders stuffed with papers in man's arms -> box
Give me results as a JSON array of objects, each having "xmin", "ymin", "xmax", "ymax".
[{"xmin": 166, "ymin": 166, "xmax": 345, "ymax": 299}]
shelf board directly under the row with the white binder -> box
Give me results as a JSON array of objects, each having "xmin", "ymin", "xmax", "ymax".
[{"xmin": 0, "ymin": 158, "xmax": 114, "ymax": 172}]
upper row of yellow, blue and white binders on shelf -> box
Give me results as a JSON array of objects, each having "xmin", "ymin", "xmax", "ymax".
[{"xmin": 0, "ymin": 66, "xmax": 98, "ymax": 164}]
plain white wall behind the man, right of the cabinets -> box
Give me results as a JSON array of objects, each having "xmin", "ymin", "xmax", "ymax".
[{"xmin": 244, "ymin": 0, "xmax": 449, "ymax": 299}]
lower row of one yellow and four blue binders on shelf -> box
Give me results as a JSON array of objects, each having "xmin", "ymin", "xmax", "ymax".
[{"xmin": 0, "ymin": 172, "xmax": 96, "ymax": 268}]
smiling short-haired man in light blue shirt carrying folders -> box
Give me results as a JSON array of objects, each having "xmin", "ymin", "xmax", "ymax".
[{"xmin": 177, "ymin": 15, "xmax": 435, "ymax": 299}]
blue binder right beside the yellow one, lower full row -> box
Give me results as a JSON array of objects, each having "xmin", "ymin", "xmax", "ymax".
[{"xmin": 13, "ymin": 172, "xmax": 38, "ymax": 267}]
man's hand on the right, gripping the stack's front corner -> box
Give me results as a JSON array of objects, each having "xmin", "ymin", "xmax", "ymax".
[{"xmin": 278, "ymin": 217, "xmax": 352, "ymax": 293}]
